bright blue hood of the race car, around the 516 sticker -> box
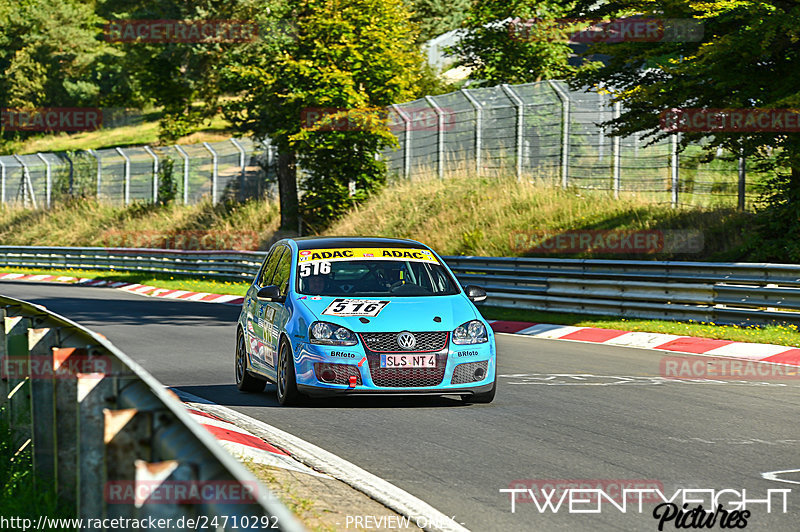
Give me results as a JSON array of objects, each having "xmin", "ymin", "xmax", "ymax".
[{"xmin": 299, "ymin": 294, "xmax": 480, "ymax": 332}]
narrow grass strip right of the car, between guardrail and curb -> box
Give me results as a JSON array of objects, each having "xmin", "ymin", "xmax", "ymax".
[{"xmin": 480, "ymin": 306, "xmax": 800, "ymax": 347}]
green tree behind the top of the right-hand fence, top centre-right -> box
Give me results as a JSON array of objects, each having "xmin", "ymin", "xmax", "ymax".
[{"xmin": 452, "ymin": 0, "xmax": 577, "ymax": 85}]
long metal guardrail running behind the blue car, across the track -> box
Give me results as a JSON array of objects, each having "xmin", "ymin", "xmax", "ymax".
[{"xmin": 0, "ymin": 246, "xmax": 800, "ymax": 324}]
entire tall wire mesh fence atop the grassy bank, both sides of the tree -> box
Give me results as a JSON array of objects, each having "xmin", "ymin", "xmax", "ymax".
[{"xmin": 0, "ymin": 81, "xmax": 764, "ymax": 209}]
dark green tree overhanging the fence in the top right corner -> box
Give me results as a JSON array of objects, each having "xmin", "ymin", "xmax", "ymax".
[{"xmin": 572, "ymin": 0, "xmax": 800, "ymax": 261}]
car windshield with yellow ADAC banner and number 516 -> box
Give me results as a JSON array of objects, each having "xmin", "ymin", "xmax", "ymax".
[{"xmin": 297, "ymin": 248, "xmax": 459, "ymax": 297}]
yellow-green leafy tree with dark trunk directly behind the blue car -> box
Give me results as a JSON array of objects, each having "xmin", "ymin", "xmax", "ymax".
[{"xmin": 219, "ymin": 0, "xmax": 421, "ymax": 230}]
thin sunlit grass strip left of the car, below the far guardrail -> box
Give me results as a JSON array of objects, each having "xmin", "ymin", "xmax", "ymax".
[{"xmin": 0, "ymin": 267, "xmax": 250, "ymax": 296}]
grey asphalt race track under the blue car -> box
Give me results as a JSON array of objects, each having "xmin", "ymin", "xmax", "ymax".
[{"xmin": 0, "ymin": 282, "xmax": 800, "ymax": 531}]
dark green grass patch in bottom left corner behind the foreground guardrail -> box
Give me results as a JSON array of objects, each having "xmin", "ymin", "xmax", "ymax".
[{"xmin": 0, "ymin": 408, "xmax": 73, "ymax": 530}]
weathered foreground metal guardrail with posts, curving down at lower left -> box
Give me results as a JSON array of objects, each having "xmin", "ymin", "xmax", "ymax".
[{"xmin": 0, "ymin": 296, "xmax": 303, "ymax": 531}]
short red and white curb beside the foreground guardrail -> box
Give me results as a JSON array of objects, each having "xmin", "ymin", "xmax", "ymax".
[{"xmin": 172, "ymin": 390, "xmax": 330, "ymax": 478}]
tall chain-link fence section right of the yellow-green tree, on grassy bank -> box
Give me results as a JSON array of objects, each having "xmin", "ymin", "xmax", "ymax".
[{"xmin": 384, "ymin": 81, "xmax": 763, "ymax": 209}]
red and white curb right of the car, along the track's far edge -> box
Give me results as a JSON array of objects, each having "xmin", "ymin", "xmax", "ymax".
[{"xmin": 488, "ymin": 320, "xmax": 800, "ymax": 366}]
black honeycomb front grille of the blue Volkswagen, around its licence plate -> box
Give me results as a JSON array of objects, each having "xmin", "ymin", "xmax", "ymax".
[{"xmin": 360, "ymin": 331, "xmax": 450, "ymax": 388}]
